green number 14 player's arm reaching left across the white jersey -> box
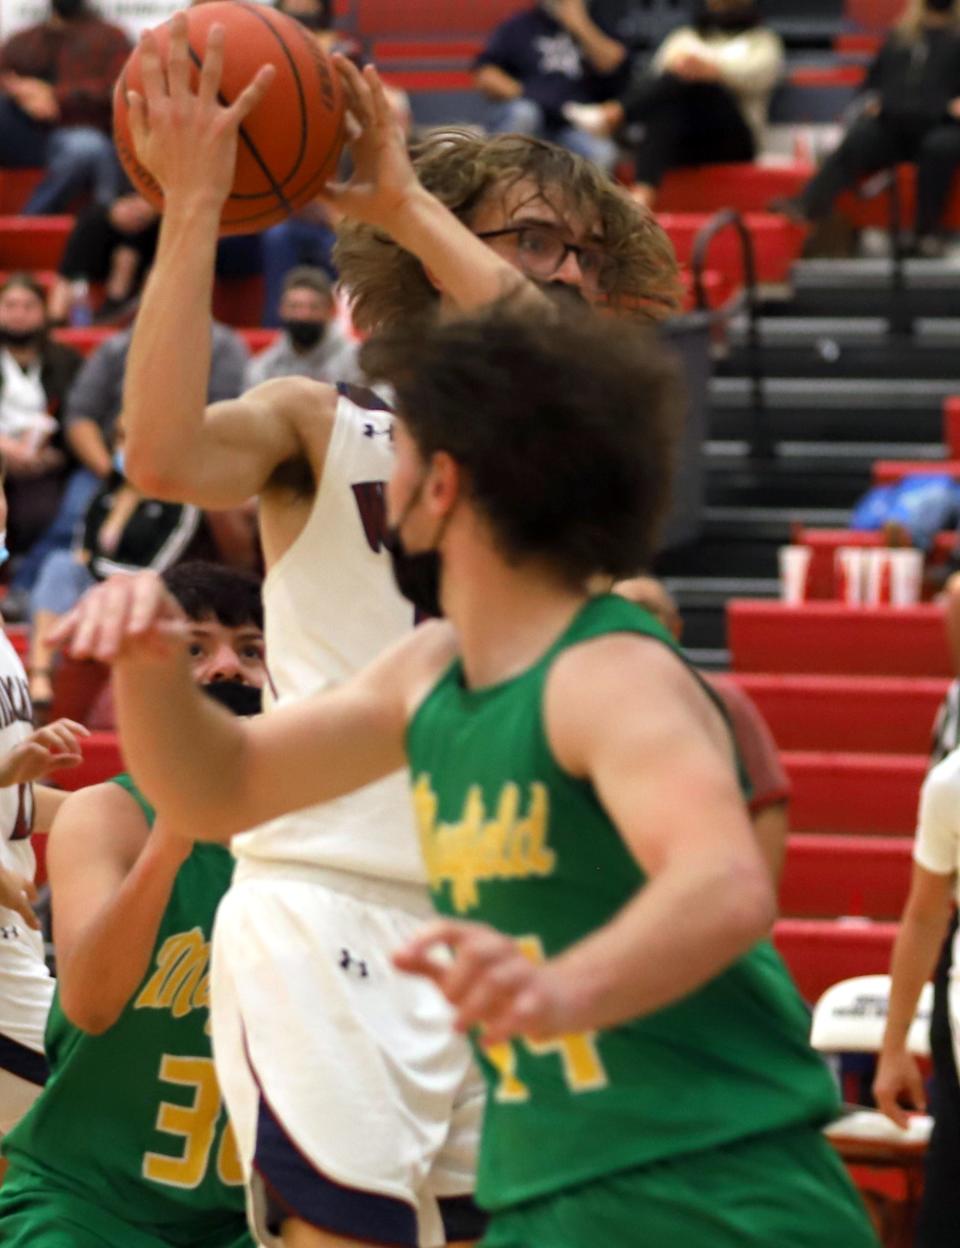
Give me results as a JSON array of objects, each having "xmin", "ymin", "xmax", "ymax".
[{"xmin": 49, "ymin": 573, "xmax": 446, "ymax": 841}]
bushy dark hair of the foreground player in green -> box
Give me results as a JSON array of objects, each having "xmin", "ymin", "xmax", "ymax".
[{"xmin": 362, "ymin": 300, "xmax": 682, "ymax": 585}]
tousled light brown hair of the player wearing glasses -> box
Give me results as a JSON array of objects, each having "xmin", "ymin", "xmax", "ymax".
[{"xmin": 333, "ymin": 130, "xmax": 682, "ymax": 329}]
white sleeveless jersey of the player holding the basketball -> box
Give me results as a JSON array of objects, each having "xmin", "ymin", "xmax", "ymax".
[{"xmin": 232, "ymin": 397, "xmax": 424, "ymax": 884}]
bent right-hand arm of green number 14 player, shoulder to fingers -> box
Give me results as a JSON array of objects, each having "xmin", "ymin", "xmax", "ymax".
[{"xmin": 398, "ymin": 636, "xmax": 775, "ymax": 1042}]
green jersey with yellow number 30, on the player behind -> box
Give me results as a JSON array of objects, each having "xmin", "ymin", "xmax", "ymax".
[{"xmin": 0, "ymin": 776, "xmax": 252, "ymax": 1248}]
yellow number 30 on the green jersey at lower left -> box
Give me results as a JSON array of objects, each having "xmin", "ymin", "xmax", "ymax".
[{"xmin": 144, "ymin": 1053, "xmax": 243, "ymax": 1188}]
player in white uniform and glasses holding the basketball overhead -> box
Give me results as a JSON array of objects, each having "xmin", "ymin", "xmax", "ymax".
[{"xmin": 117, "ymin": 17, "xmax": 677, "ymax": 1248}]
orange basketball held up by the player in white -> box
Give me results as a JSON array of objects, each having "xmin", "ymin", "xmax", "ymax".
[{"xmin": 114, "ymin": 0, "xmax": 343, "ymax": 235}]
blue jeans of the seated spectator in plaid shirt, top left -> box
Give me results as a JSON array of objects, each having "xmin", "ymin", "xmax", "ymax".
[{"xmin": 0, "ymin": 96, "xmax": 124, "ymax": 217}]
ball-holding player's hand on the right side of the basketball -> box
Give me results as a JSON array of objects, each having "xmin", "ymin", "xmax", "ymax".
[{"xmin": 317, "ymin": 54, "xmax": 421, "ymax": 231}]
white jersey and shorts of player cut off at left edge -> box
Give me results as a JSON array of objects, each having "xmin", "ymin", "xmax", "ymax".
[{"xmin": 0, "ymin": 630, "xmax": 54, "ymax": 1052}]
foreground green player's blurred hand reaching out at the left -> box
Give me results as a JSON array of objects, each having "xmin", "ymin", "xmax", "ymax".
[{"xmin": 50, "ymin": 572, "xmax": 189, "ymax": 663}]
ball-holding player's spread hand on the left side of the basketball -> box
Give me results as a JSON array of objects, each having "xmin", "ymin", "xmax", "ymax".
[{"xmin": 127, "ymin": 12, "xmax": 276, "ymax": 207}]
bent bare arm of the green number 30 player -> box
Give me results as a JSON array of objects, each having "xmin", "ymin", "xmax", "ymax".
[{"xmin": 47, "ymin": 784, "xmax": 190, "ymax": 1035}]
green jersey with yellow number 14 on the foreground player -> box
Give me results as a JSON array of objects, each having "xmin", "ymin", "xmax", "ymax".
[{"xmin": 408, "ymin": 597, "xmax": 839, "ymax": 1209}]
